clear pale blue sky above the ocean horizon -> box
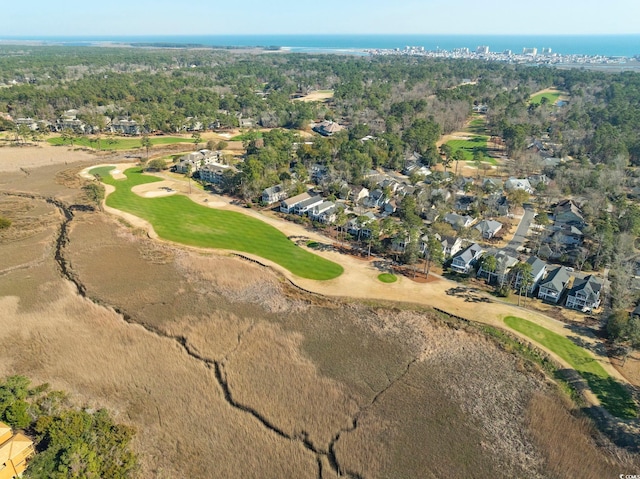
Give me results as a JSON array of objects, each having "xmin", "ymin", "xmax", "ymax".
[{"xmin": 5, "ymin": 0, "xmax": 640, "ymax": 38}]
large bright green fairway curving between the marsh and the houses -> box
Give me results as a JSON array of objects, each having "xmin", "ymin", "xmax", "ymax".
[{"xmin": 91, "ymin": 166, "xmax": 343, "ymax": 280}]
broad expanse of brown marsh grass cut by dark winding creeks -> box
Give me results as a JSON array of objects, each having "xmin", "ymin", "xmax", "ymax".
[{"xmin": 0, "ymin": 168, "xmax": 627, "ymax": 479}]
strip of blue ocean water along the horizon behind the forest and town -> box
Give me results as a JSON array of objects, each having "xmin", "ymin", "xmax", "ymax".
[{"xmin": 5, "ymin": 34, "xmax": 640, "ymax": 57}]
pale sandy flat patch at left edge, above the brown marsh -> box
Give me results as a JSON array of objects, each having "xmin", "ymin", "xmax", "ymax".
[{"xmin": 0, "ymin": 143, "xmax": 95, "ymax": 172}]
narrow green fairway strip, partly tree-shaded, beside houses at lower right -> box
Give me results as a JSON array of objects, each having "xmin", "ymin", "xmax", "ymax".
[{"xmin": 504, "ymin": 316, "xmax": 638, "ymax": 419}]
